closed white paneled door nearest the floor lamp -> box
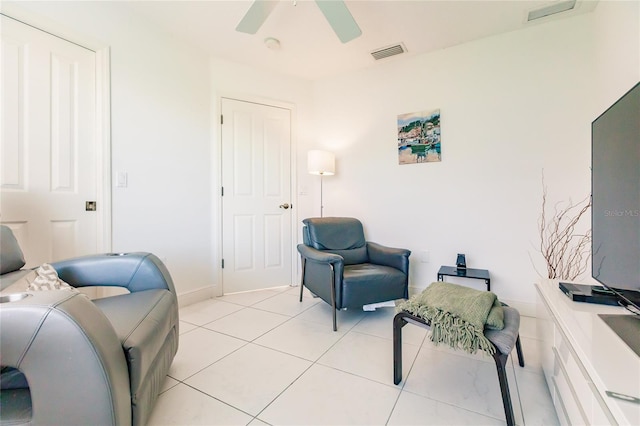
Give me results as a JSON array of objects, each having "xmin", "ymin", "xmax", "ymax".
[{"xmin": 222, "ymin": 98, "xmax": 293, "ymax": 294}]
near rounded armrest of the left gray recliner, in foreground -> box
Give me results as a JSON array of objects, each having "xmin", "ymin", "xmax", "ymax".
[{"xmin": 0, "ymin": 290, "xmax": 131, "ymax": 426}]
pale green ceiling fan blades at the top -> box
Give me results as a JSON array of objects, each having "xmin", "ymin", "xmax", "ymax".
[{"xmin": 236, "ymin": 0, "xmax": 362, "ymax": 43}]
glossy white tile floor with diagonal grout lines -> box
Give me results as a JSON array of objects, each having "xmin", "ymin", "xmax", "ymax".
[{"xmin": 149, "ymin": 287, "xmax": 558, "ymax": 425}]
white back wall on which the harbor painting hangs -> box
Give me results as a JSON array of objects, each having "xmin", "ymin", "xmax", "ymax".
[{"xmin": 314, "ymin": 2, "xmax": 638, "ymax": 312}]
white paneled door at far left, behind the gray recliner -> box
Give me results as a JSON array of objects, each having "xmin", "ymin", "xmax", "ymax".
[{"xmin": 0, "ymin": 16, "xmax": 101, "ymax": 267}]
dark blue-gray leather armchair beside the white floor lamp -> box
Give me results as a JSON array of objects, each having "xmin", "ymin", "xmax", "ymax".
[{"xmin": 298, "ymin": 217, "xmax": 411, "ymax": 331}]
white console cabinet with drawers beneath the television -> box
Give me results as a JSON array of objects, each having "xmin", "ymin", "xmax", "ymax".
[{"xmin": 536, "ymin": 280, "xmax": 640, "ymax": 425}]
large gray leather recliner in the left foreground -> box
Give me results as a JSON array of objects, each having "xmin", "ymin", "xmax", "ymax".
[{"xmin": 0, "ymin": 226, "xmax": 179, "ymax": 425}]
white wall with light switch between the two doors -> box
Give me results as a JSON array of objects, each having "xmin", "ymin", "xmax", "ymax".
[{"xmin": 3, "ymin": 2, "xmax": 215, "ymax": 299}]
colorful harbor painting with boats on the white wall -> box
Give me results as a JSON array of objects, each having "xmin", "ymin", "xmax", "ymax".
[{"xmin": 398, "ymin": 109, "xmax": 442, "ymax": 164}]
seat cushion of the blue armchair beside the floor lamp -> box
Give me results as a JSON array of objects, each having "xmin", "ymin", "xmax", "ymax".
[{"xmin": 342, "ymin": 263, "xmax": 407, "ymax": 308}]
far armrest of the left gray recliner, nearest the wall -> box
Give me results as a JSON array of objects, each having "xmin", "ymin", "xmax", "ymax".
[{"xmin": 51, "ymin": 252, "xmax": 175, "ymax": 294}]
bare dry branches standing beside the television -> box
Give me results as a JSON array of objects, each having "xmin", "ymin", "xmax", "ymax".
[{"xmin": 538, "ymin": 175, "xmax": 591, "ymax": 281}]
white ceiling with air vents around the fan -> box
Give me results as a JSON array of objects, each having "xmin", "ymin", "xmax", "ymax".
[{"xmin": 120, "ymin": 0, "xmax": 597, "ymax": 80}]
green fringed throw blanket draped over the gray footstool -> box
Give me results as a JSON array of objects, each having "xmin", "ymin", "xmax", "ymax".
[{"xmin": 396, "ymin": 281, "xmax": 504, "ymax": 355}]
